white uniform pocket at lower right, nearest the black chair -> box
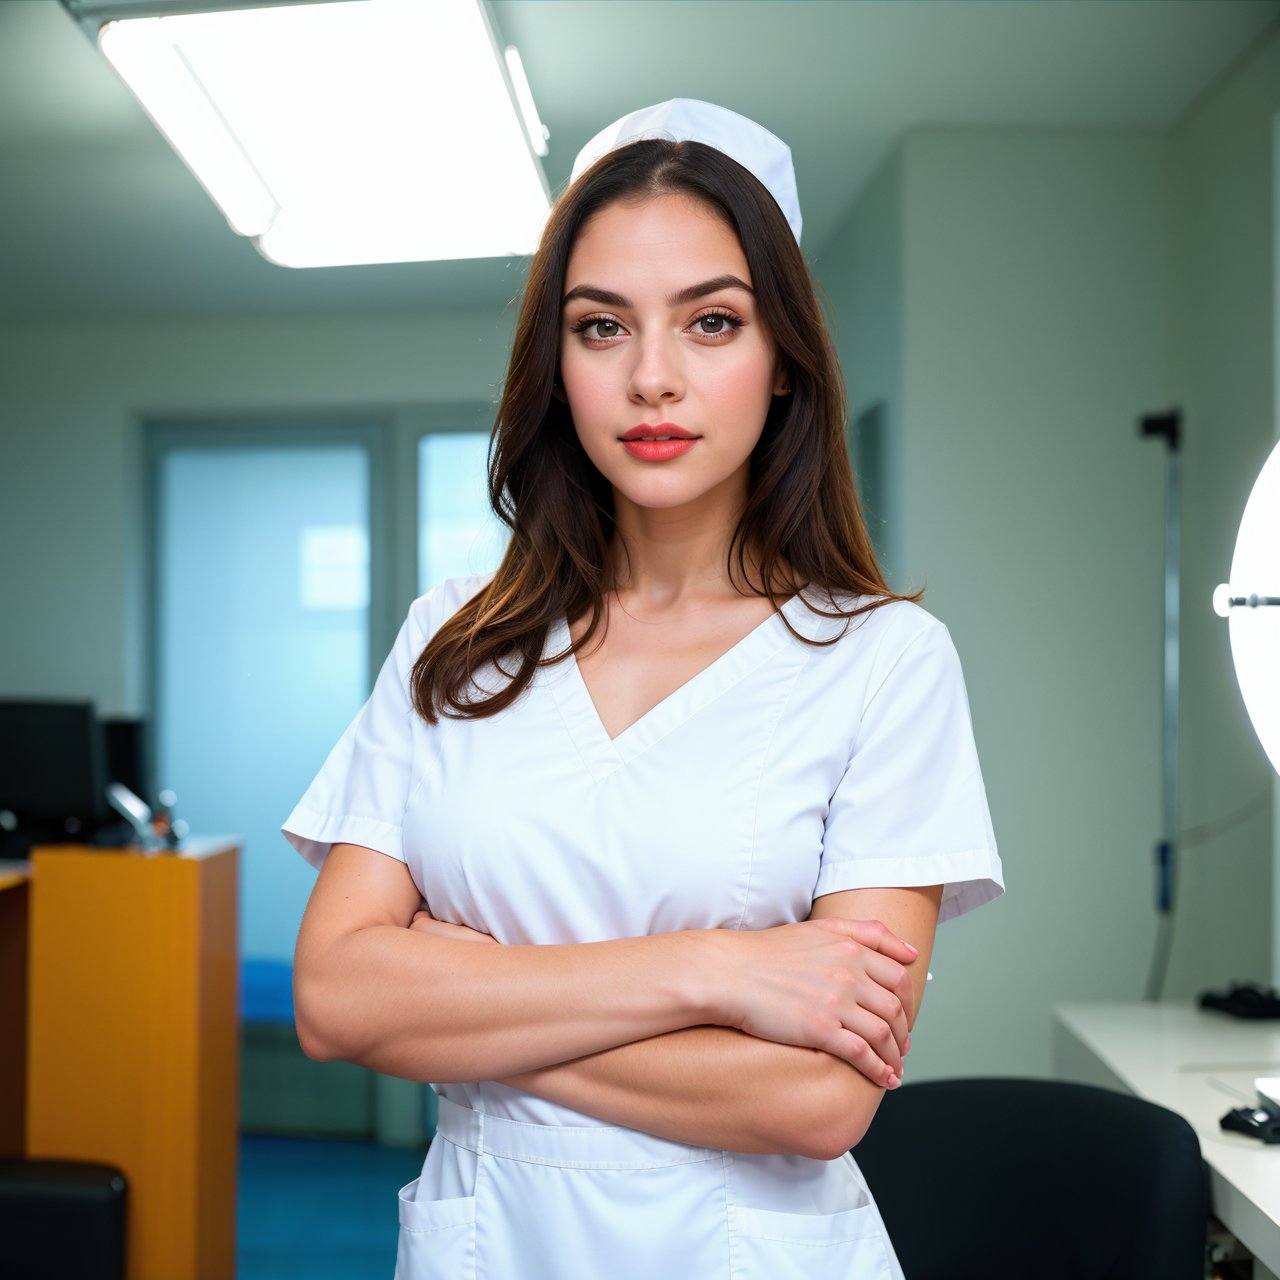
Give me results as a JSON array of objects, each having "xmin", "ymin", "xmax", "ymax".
[{"xmin": 731, "ymin": 1204, "xmax": 893, "ymax": 1280}]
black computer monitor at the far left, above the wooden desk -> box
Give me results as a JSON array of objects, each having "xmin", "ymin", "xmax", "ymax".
[{"xmin": 0, "ymin": 699, "xmax": 113, "ymax": 838}]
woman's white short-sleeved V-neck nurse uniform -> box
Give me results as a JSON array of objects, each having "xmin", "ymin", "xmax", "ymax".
[{"xmin": 283, "ymin": 577, "xmax": 1004, "ymax": 1280}]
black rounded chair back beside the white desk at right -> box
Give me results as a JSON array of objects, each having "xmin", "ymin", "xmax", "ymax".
[{"xmin": 854, "ymin": 1079, "xmax": 1210, "ymax": 1280}]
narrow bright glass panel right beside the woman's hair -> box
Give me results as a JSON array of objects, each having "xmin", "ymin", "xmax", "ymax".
[{"xmin": 417, "ymin": 431, "xmax": 509, "ymax": 594}]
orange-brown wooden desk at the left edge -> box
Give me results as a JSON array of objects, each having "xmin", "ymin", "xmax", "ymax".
[{"xmin": 0, "ymin": 841, "xmax": 239, "ymax": 1280}]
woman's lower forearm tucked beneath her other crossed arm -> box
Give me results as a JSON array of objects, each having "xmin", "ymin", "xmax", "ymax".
[{"xmin": 502, "ymin": 1027, "xmax": 884, "ymax": 1160}]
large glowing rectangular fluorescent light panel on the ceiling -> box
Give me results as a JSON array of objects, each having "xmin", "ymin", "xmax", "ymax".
[{"xmin": 90, "ymin": 0, "xmax": 550, "ymax": 266}]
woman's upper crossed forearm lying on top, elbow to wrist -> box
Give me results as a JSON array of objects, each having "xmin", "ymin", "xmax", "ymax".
[{"xmin": 294, "ymin": 925, "xmax": 717, "ymax": 1083}]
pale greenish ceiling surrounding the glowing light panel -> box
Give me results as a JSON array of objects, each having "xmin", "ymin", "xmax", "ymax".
[{"xmin": 0, "ymin": 0, "xmax": 1280, "ymax": 321}]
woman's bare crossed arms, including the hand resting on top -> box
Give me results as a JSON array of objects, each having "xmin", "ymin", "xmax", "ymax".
[{"xmin": 294, "ymin": 844, "xmax": 942, "ymax": 1160}]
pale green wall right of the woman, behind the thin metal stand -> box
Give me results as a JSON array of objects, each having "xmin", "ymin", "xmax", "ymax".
[{"xmin": 818, "ymin": 22, "xmax": 1280, "ymax": 1079}]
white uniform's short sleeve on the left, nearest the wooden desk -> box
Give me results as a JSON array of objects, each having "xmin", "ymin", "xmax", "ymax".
[{"xmin": 280, "ymin": 596, "xmax": 429, "ymax": 870}]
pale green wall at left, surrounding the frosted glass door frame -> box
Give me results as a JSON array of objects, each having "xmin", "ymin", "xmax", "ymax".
[{"xmin": 0, "ymin": 304, "xmax": 512, "ymax": 716}]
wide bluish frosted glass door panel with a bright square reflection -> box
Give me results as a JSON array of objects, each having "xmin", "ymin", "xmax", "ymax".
[{"xmin": 156, "ymin": 445, "xmax": 371, "ymax": 960}]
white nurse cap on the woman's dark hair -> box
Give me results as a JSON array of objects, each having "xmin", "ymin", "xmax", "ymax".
[{"xmin": 570, "ymin": 97, "xmax": 801, "ymax": 243}]
